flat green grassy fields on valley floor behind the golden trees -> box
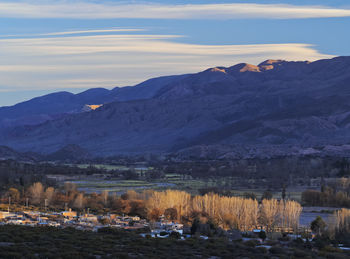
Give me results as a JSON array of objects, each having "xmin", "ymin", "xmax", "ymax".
[{"xmin": 58, "ymin": 164, "xmax": 304, "ymax": 202}]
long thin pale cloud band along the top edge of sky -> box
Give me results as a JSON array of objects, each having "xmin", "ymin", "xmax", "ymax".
[{"xmin": 0, "ymin": 1, "xmax": 350, "ymax": 19}]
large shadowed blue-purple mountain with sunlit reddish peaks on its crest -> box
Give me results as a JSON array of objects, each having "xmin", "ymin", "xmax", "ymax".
[{"xmin": 0, "ymin": 57, "xmax": 350, "ymax": 156}]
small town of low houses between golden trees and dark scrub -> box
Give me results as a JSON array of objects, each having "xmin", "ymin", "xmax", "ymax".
[{"xmin": 0, "ymin": 206, "xmax": 334, "ymax": 243}]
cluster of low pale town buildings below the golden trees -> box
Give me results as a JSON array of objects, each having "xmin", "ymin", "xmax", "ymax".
[{"xmin": 0, "ymin": 209, "xmax": 322, "ymax": 246}]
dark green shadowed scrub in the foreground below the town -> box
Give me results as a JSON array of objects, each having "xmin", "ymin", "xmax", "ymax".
[{"xmin": 0, "ymin": 226, "xmax": 350, "ymax": 258}]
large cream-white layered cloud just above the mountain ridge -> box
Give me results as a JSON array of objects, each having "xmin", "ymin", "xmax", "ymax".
[{"xmin": 0, "ymin": 33, "xmax": 331, "ymax": 91}]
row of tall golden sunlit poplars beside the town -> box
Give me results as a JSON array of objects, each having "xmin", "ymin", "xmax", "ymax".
[{"xmin": 147, "ymin": 190, "xmax": 302, "ymax": 231}]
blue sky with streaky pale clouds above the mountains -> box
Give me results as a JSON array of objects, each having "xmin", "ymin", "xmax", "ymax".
[{"xmin": 0, "ymin": 0, "xmax": 350, "ymax": 106}]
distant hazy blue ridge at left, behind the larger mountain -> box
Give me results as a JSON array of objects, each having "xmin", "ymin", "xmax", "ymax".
[{"xmin": 0, "ymin": 75, "xmax": 186, "ymax": 128}]
